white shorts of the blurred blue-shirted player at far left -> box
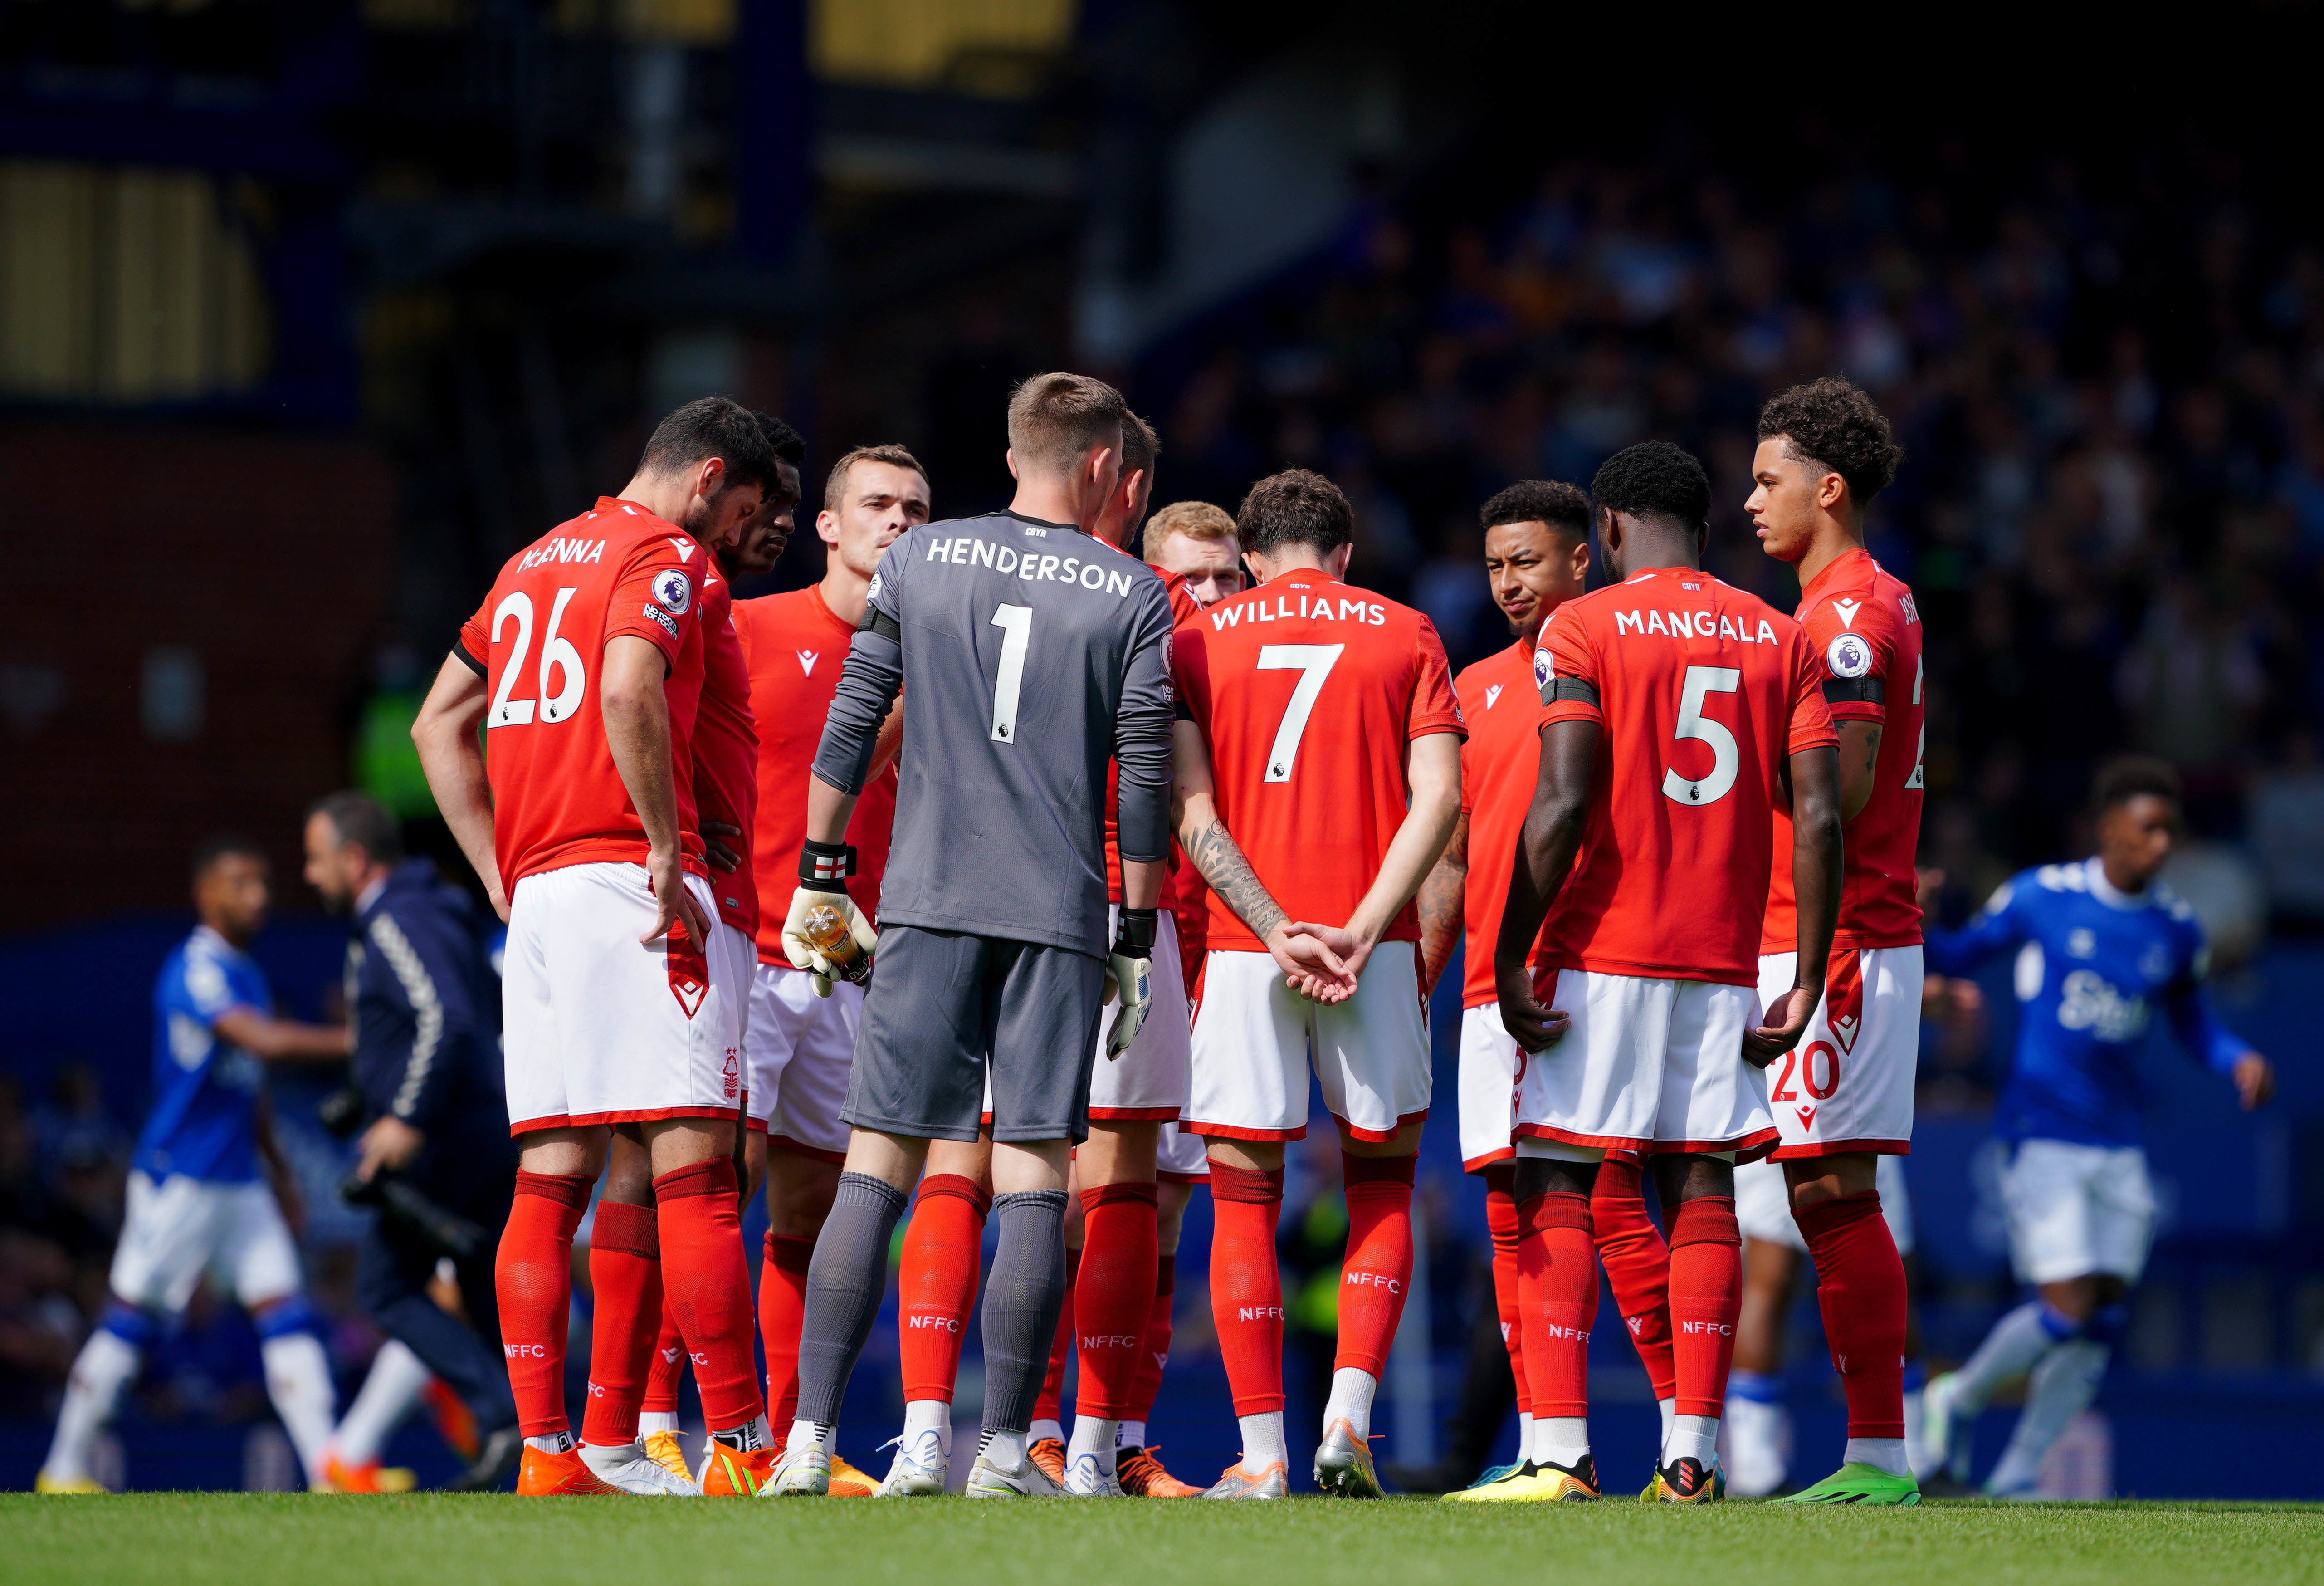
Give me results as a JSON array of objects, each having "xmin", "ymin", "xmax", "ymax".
[{"xmin": 112, "ymin": 1172, "xmax": 302, "ymax": 1316}]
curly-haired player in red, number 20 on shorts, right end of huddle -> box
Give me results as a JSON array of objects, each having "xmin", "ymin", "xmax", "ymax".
[{"xmin": 1736, "ymin": 379, "xmax": 1924, "ymax": 1505}]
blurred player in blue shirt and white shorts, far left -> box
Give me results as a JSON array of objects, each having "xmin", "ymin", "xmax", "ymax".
[{"xmin": 37, "ymin": 837, "xmax": 346, "ymax": 1493}]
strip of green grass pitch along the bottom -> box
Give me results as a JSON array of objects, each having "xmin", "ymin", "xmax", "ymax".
[{"xmin": 0, "ymin": 1493, "xmax": 2324, "ymax": 1586}]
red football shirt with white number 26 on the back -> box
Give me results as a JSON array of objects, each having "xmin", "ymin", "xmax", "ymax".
[{"xmin": 460, "ymin": 495, "xmax": 709, "ymax": 893}]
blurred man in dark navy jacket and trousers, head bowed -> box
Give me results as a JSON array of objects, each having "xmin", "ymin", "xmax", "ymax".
[{"xmin": 307, "ymin": 791, "xmax": 516, "ymax": 1474}]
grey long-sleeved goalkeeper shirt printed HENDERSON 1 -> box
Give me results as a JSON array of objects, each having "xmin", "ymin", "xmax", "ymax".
[{"xmin": 816, "ymin": 512, "xmax": 1171, "ymax": 956}]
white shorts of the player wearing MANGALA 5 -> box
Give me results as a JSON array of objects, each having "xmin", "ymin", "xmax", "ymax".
[{"xmin": 1518, "ymin": 970, "xmax": 1776, "ymax": 1160}]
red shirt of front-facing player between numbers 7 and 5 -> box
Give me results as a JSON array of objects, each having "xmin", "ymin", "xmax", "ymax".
[{"xmin": 1453, "ymin": 640, "xmax": 1548, "ymax": 1007}]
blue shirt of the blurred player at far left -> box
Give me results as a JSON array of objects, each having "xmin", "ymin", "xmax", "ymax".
[{"xmin": 135, "ymin": 925, "xmax": 274, "ymax": 1184}]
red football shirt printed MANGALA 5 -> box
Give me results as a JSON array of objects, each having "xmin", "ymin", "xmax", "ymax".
[{"xmin": 1534, "ymin": 568, "xmax": 1841, "ymax": 986}]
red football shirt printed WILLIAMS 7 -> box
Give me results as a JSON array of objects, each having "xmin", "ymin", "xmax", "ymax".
[{"xmin": 1171, "ymin": 570, "xmax": 1466, "ymax": 951}]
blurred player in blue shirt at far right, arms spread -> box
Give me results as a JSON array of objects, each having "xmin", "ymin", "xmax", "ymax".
[{"xmin": 1927, "ymin": 756, "xmax": 2275, "ymax": 1498}]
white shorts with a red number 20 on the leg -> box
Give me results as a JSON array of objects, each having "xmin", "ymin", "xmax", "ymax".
[{"xmin": 1759, "ymin": 942, "xmax": 1922, "ymax": 1160}]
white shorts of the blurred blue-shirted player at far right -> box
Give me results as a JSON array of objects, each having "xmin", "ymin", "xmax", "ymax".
[{"xmin": 2001, "ymin": 1140, "xmax": 2154, "ymax": 1284}]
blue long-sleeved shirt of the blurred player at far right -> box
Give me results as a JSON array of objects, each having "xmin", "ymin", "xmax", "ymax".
[{"xmin": 1924, "ymin": 858, "xmax": 2250, "ymax": 1146}]
